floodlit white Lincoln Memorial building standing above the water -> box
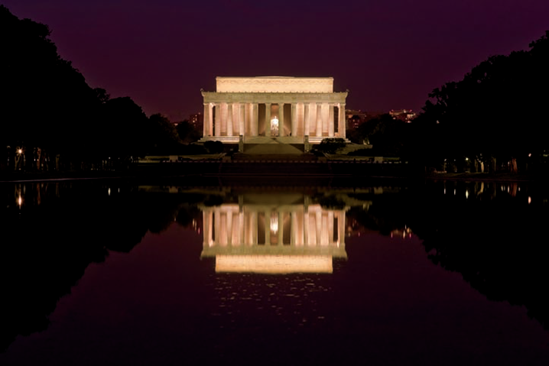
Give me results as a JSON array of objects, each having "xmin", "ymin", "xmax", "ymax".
[{"xmin": 201, "ymin": 76, "xmax": 347, "ymax": 143}]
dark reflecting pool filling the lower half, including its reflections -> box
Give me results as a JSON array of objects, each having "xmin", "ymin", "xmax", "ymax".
[{"xmin": 0, "ymin": 182, "xmax": 549, "ymax": 365}]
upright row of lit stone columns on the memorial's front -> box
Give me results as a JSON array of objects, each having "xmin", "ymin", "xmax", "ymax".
[{"xmin": 203, "ymin": 102, "xmax": 347, "ymax": 138}]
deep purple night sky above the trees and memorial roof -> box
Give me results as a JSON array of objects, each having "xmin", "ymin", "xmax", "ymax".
[{"xmin": 0, "ymin": 0, "xmax": 549, "ymax": 121}]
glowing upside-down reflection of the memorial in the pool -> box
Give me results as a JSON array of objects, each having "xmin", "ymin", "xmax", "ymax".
[{"xmin": 199, "ymin": 193, "xmax": 347, "ymax": 273}]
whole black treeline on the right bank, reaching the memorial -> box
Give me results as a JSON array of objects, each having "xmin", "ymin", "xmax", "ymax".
[{"xmin": 349, "ymin": 31, "xmax": 549, "ymax": 172}]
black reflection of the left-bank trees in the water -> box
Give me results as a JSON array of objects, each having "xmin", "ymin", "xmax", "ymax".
[{"xmin": 0, "ymin": 182, "xmax": 207, "ymax": 349}]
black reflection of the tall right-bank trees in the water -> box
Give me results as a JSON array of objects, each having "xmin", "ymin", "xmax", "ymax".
[{"xmin": 410, "ymin": 183, "xmax": 549, "ymax": 329}]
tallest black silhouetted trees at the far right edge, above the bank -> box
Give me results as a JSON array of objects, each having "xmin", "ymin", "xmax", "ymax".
[{"xmin": 413, "ymin": 31, "xmax": 549, "ymax": 172}]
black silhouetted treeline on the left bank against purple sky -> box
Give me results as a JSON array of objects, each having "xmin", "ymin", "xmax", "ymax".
[{"xmin": 0, "ymin": 5, "xmax": 197, "ymax": 170}]
